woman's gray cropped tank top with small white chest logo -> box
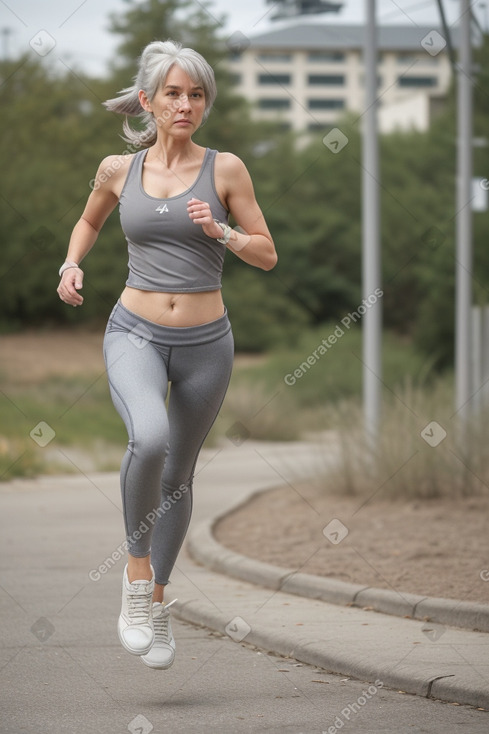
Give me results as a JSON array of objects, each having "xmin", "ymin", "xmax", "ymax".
[{"xmin": 119, "ymin": 148, "xmax": 228, "ymax": 293}]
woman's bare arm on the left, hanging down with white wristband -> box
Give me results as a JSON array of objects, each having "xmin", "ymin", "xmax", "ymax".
[{"xmin": 57, "ymin": 156, "xmax": 125, "ymax": 306}]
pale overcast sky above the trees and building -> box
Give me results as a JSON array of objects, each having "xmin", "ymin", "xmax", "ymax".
[{"xmin": 0, "ymin": 0, "xmax": 489, "ymax": 75}]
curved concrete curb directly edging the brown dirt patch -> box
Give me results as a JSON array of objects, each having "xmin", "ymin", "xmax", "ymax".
[{"xmin": 187, "ymin": 490, "xmax": 489, "ymax": 632}]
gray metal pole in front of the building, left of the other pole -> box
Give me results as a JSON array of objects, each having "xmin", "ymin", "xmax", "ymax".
[{"xmin": 362, "ymin": 0, "xmax": 382, "ymax": 447}]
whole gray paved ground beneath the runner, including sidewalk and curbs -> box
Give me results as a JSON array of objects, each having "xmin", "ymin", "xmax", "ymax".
[{"xmin": 0, "ymin": 436, "xmax": 489, "ymax": 734}]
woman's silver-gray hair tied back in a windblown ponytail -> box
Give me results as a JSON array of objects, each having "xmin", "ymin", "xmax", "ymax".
[{"xmin": 103, "ymin": 40, "xmax": 217, "ymax": 147}]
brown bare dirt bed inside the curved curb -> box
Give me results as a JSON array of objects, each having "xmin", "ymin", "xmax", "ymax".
[{"xmin": 216, "ymin": 484, "xmax": 489, "ymax": 604}]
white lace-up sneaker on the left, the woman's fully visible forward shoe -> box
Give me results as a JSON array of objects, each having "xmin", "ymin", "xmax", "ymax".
[{"xmin": 117, "ymin": 566, "xmax": 155, "ymax": 655}]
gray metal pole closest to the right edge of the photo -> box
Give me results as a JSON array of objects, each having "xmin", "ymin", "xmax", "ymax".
[{"xmin": 455, "ymin": 0, "xmax": 472, "ymax": 422}]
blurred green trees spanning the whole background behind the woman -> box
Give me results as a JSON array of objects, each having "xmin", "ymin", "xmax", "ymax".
[{"xmin": 0, "ymin": 0, "xmax": 489, "ymax": 366}]
